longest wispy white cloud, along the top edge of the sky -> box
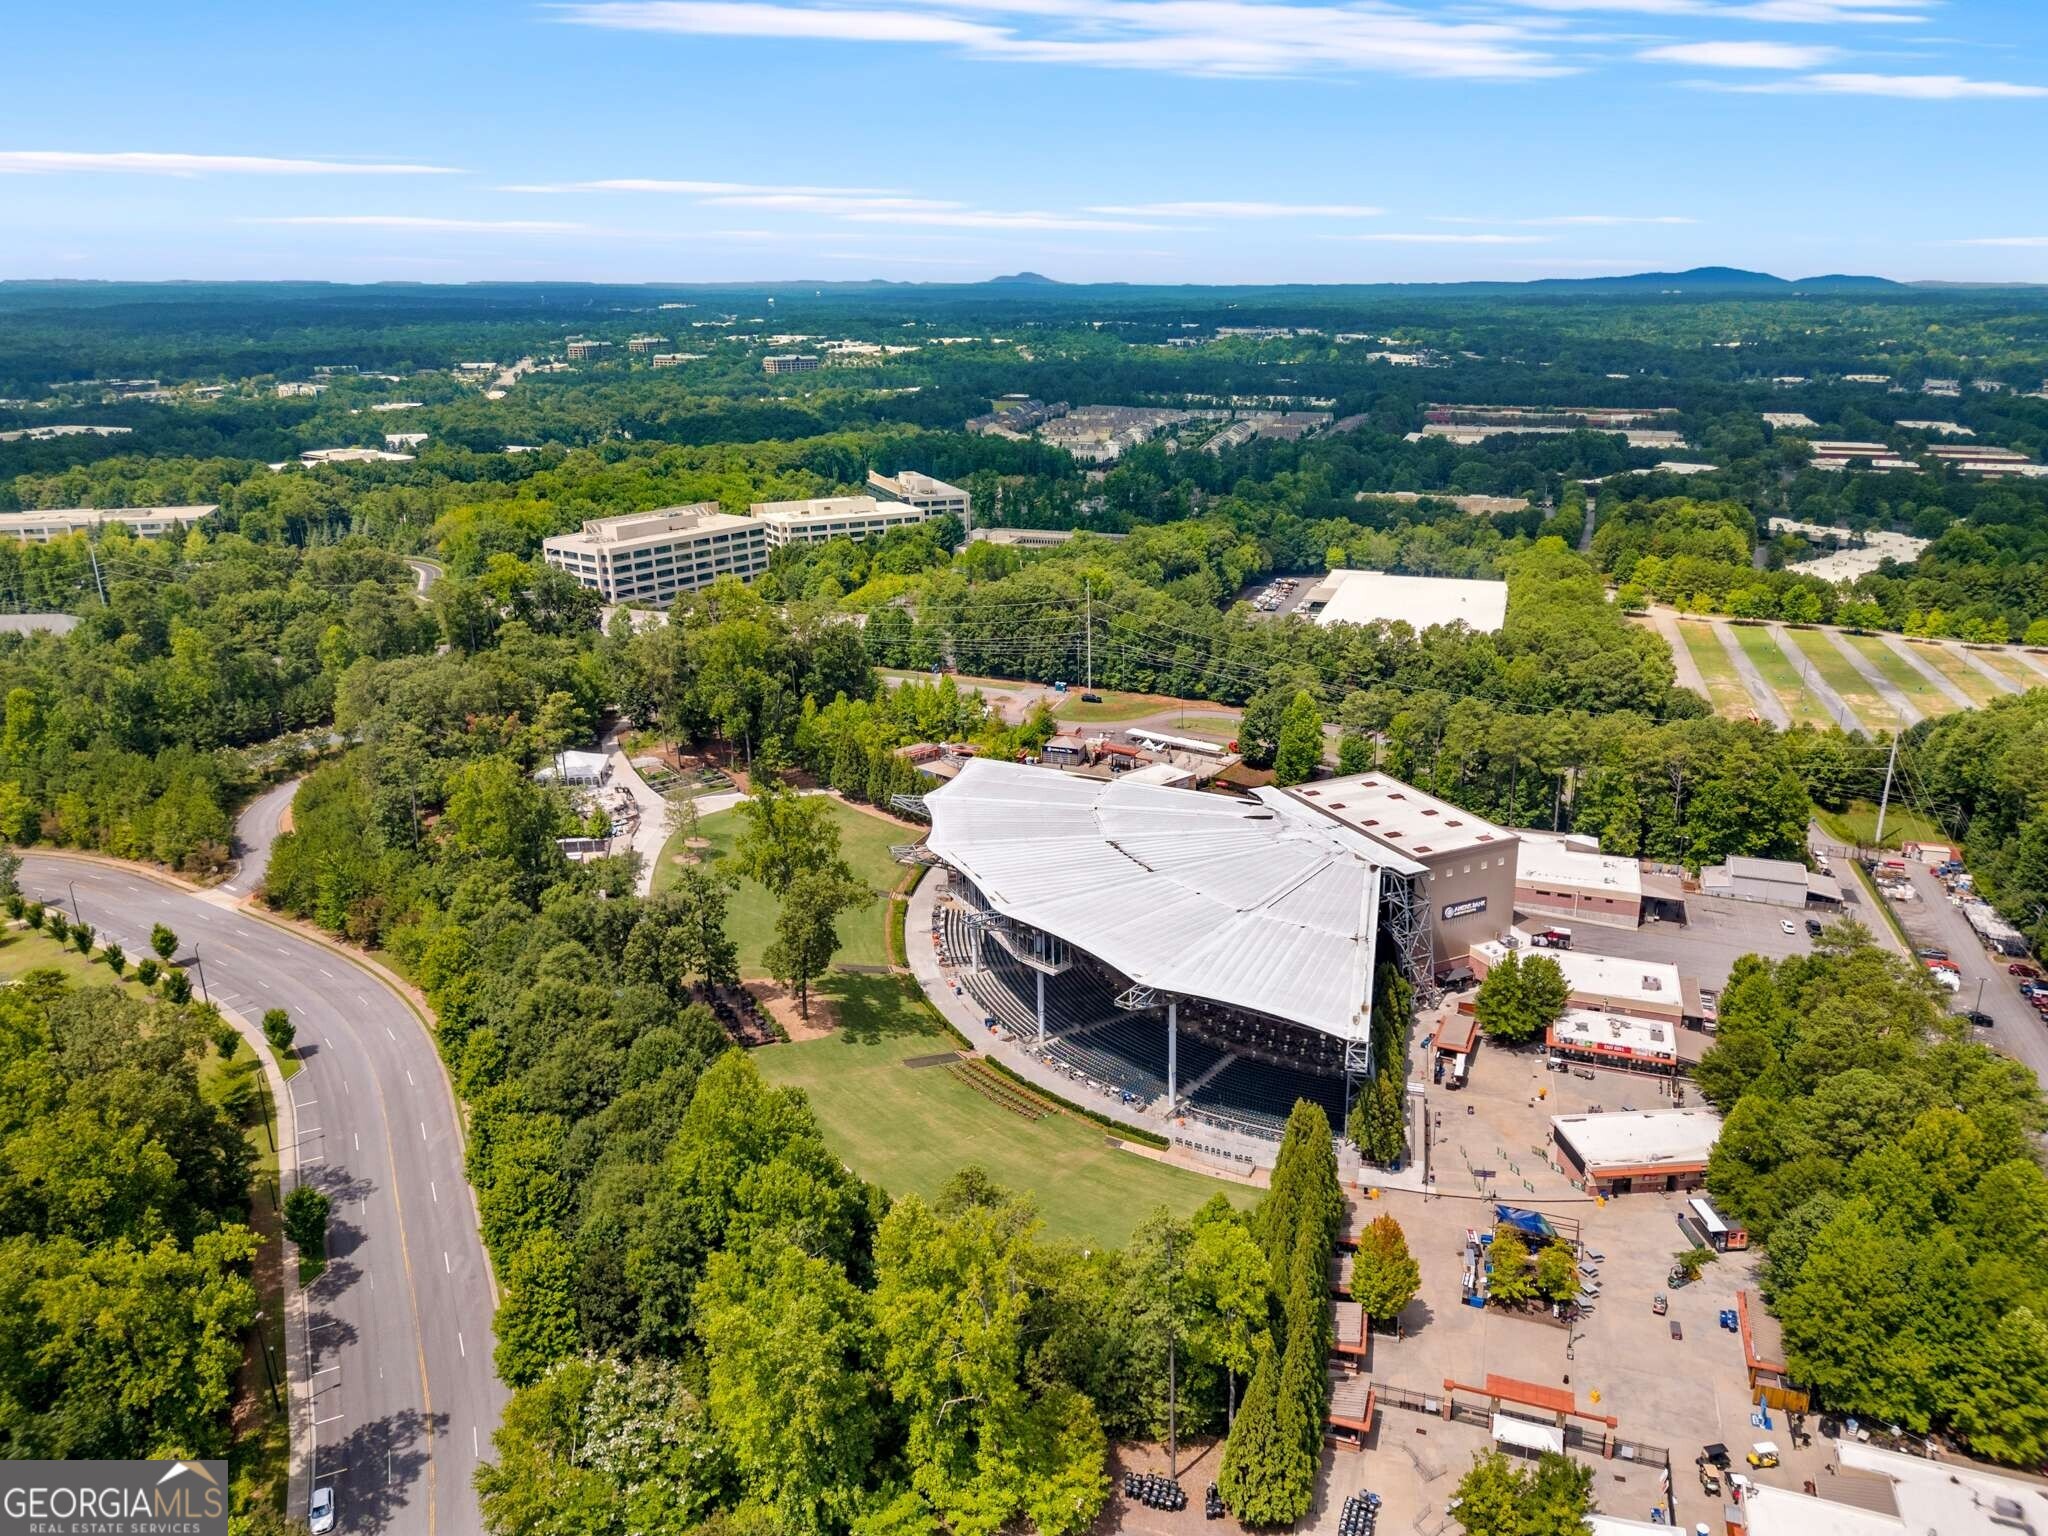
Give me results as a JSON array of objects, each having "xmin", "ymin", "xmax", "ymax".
[{"xmin": 557, "ymin": 0, "xmax": 1577, "ymax": 80}]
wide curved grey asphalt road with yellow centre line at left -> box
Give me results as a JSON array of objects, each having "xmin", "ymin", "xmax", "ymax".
[{"xmin": 23, "ymin": 854, "xmax": 506, "ymax": 1536}]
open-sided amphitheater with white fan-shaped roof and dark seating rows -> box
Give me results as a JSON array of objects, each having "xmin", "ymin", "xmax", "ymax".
[{"xmin": 915, "ymin": 760, "xmax": 1458, "ymax": 1147}]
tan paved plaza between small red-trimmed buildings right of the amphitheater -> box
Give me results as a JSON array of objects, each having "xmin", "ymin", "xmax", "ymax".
[{"xmin": 1364, "ymin": 1040, "xmax": 1827, "ymax": 1532}]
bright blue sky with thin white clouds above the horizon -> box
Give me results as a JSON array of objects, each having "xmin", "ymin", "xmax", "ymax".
[{"xmin": 0, "ymin": 0, "xmax": 2048, "ymax": 283}]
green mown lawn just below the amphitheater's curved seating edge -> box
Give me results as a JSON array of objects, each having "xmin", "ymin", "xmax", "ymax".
[{"xmin": 754, "ymin": 975, "xmax": 1257, "ymax": 1243}]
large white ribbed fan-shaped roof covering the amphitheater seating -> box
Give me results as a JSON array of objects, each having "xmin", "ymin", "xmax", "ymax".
[{"xmin": 926, "ymin": 758, "xmax": 1421, "ymax": 1040}]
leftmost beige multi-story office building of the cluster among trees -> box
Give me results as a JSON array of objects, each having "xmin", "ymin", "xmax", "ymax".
[{"xmin": 541, "ymin": 502, "xmax": 768, "ymax": 602}]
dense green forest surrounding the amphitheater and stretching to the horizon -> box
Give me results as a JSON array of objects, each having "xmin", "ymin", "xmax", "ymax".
[{"xmin": 0, "ymin": 285, "xmax": 2048, "ymax": 1536}]
